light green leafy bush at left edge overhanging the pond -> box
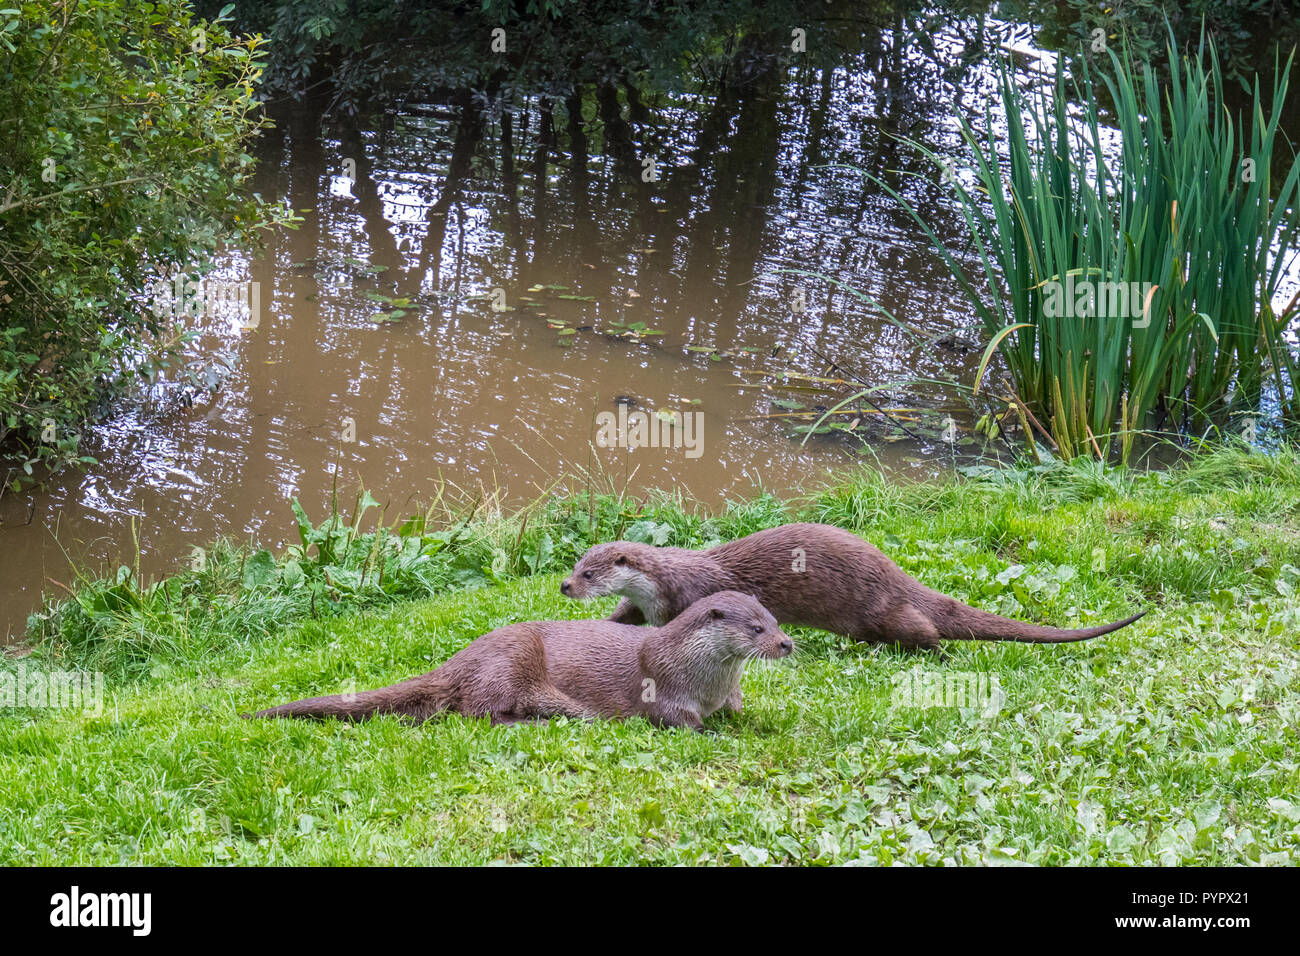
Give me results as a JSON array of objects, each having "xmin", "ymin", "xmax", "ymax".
[{"xmin": 0, "ymin": 0, "xmax": 286, "ymax": 475}]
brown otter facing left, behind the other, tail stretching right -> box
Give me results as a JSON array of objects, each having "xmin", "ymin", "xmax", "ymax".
[{"xmin": 560, "ymin": 524, "xmax": 1145, "ymax": 650}]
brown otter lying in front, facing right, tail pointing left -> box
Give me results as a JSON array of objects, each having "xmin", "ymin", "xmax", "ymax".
[{"xmin": 245, "ymin": 591, "xmax": 792, "ymax": 730}]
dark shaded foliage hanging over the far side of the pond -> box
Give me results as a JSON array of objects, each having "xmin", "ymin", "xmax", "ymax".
[{"xmin": 196, "ymin": 0, "xmax": 806, "ymax": 112}]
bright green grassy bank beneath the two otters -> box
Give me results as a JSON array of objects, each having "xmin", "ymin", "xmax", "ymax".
[{"xmin": 0, "ymin": 453, "xmax": 1300, "ymax": 864}]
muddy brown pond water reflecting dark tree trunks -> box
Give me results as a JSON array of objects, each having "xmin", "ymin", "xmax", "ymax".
[{"xmin": 0, "ymin": 14, "xmax": 1294, "ymax": 640}]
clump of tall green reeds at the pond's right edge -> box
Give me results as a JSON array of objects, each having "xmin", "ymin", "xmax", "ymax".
[{"xmin": 868, "ymin": 31, "xmax": 1300, "ymax": 460}]
